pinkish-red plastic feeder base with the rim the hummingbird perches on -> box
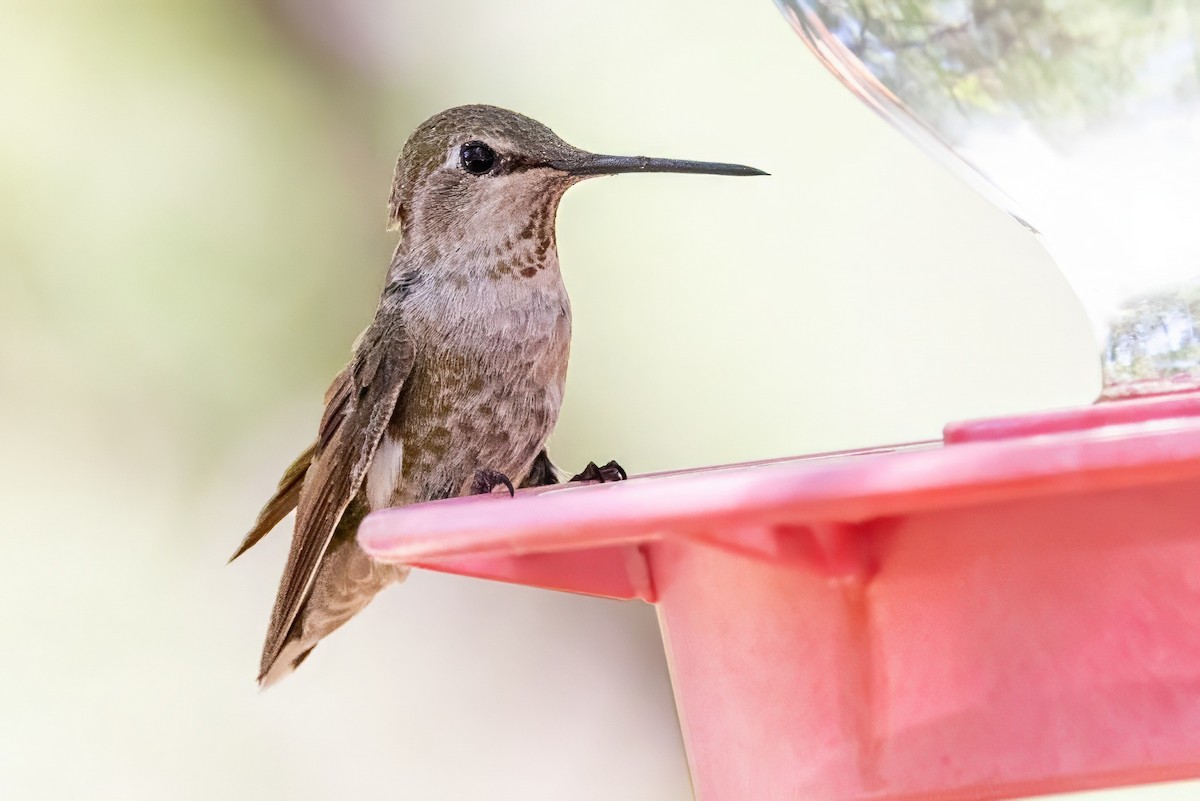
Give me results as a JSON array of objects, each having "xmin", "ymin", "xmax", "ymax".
[{"xmin": 359, "ymin": 395, "xmax": 1200, "ymax": 801}]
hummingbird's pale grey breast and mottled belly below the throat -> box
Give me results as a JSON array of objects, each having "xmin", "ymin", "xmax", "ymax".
[{"xmin": 367, "ymin": 275, "xmax": 571, "ymax": 508}]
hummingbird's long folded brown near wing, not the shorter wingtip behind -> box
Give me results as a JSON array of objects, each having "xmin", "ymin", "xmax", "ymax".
[{"xmin": 262, "ymin": 318, "xmax": 413, "ymax": 671}]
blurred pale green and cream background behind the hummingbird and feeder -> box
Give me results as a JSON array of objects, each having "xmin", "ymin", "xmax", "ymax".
[{"xmin": 0, "ymin": 0, "xmax": 1196, "ymax": 801}]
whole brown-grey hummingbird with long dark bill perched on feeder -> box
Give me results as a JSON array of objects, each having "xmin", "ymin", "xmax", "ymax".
[{"xmin": 230, "ymin": 106, "xmax": 766, "ymax": 687}]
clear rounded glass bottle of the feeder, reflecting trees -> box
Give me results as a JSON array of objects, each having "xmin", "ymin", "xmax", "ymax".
[{"xmin": 776, "ymin": 0, "xmax": 1200, "ymax": 397}]
